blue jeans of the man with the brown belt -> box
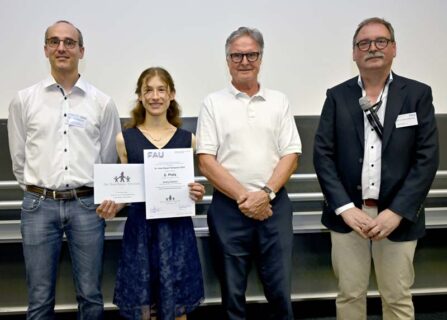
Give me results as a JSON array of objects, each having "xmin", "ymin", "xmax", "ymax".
[{"xmin": 21, "ymin": 192, "xmax": 105, "ymax": 320}]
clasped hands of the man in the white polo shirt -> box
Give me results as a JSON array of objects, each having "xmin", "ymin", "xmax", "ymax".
[{"xmin": 237, "ymin": 190, "xmax": 273, "ymax": 221}]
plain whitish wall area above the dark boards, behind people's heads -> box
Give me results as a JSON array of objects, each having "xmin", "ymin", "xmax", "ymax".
[{"xmin": 0, "ymin": 0, "xmax": 447, "ymax": 118}]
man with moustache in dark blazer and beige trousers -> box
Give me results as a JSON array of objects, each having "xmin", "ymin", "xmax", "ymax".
[{"xmin": 314, "ymin": 18, "xmax": 439, "ymax": 320}]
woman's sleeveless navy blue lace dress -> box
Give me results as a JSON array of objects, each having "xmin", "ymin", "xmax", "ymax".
[{"xmin": 113, "ymin": 128, "xmax": 204, "ymax": 320}]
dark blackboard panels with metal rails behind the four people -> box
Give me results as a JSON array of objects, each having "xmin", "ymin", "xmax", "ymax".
[{"xmin": 0, "ymin": 115, "xmax": 447, "ymax": 315}]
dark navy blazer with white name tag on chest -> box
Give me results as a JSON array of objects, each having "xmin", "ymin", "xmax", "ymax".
[{"xmin": 314, "ymin": 74, "xmax": 439, "ymax": 241}]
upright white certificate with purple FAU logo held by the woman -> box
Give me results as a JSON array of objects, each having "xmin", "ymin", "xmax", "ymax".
[{"xmin": 144, "ymin": 148, "xmax": 196, "ymax": 219}]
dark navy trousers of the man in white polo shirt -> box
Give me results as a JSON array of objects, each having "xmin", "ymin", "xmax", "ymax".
[{"xmin": 208, "ymin": 188, "xmax": 293, "ymax": 320}]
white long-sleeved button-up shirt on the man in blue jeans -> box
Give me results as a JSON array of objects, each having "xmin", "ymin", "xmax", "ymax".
[{"xmin": 8, "ymin": 77, "xmax": 121, "ymax": 190}]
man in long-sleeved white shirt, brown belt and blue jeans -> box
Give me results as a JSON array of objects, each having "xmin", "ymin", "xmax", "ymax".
[{"xmin": 8, "ymin": 21, "xmax": 121, "ymax": 319}]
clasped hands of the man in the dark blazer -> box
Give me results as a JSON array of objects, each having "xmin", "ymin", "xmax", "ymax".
[{"xmin": 340, "ymin": 207, "xmax": 402, "ymax": 240}]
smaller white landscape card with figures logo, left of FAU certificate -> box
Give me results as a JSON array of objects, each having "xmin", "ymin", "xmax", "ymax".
[{"xmin": 93, "ymin": 163, "xmax": 145, "ymax": 203}]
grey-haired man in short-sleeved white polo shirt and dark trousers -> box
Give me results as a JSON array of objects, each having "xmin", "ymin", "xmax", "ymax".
[{"xmin": 197, "ymin": 27, "xmax": 301, "ymax": 320}]
